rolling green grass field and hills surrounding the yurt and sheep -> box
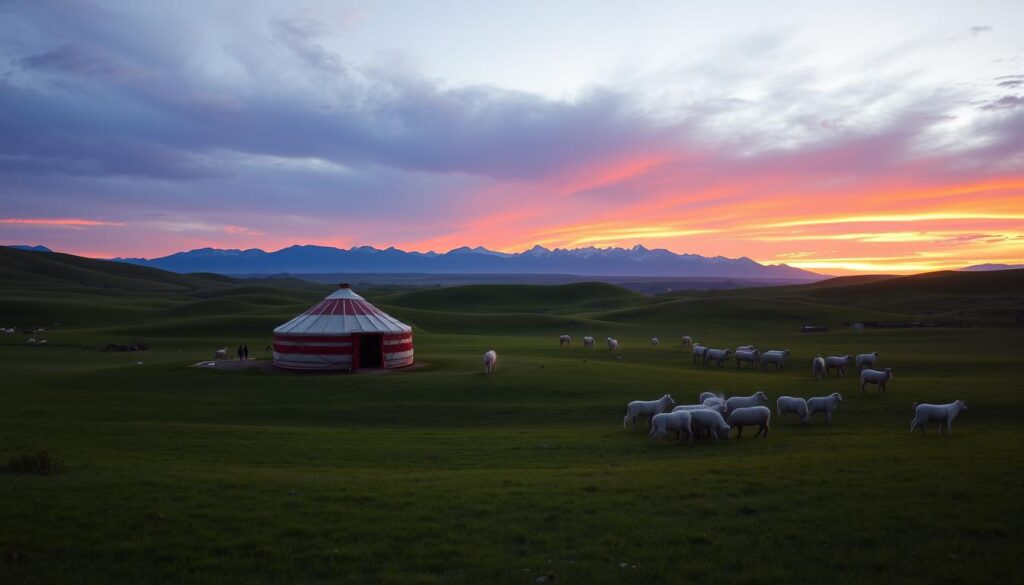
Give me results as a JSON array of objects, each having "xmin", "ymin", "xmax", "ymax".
[{"xmin": 0, "ymin": 249, "xmax": 1024, "ymax": 585}]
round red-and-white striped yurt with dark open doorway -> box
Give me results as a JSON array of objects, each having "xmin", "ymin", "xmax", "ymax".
[{"xmin": 273, "ymin": 284, "xmax": 413, "ymax": 370}]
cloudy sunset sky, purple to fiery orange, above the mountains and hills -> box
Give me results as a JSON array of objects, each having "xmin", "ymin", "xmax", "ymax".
[{"xmin": 0, "ymin": 0, "xmax": 1024, "ymax": 274}]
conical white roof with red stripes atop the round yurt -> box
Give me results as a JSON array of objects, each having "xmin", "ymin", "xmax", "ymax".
[{"xmin": 273, "ymin": 285, "xmax": 413, "ymax": 336}]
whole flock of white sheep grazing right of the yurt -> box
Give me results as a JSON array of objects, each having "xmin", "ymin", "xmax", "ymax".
[{"xmin": 483, "ymin": 335, "xmax": 968, "ymax": 442}]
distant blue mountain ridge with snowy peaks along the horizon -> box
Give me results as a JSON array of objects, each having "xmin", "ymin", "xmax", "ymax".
[{"xmin": 114, "ymin": 246, "xmax": 825, "ymax": 281}]
